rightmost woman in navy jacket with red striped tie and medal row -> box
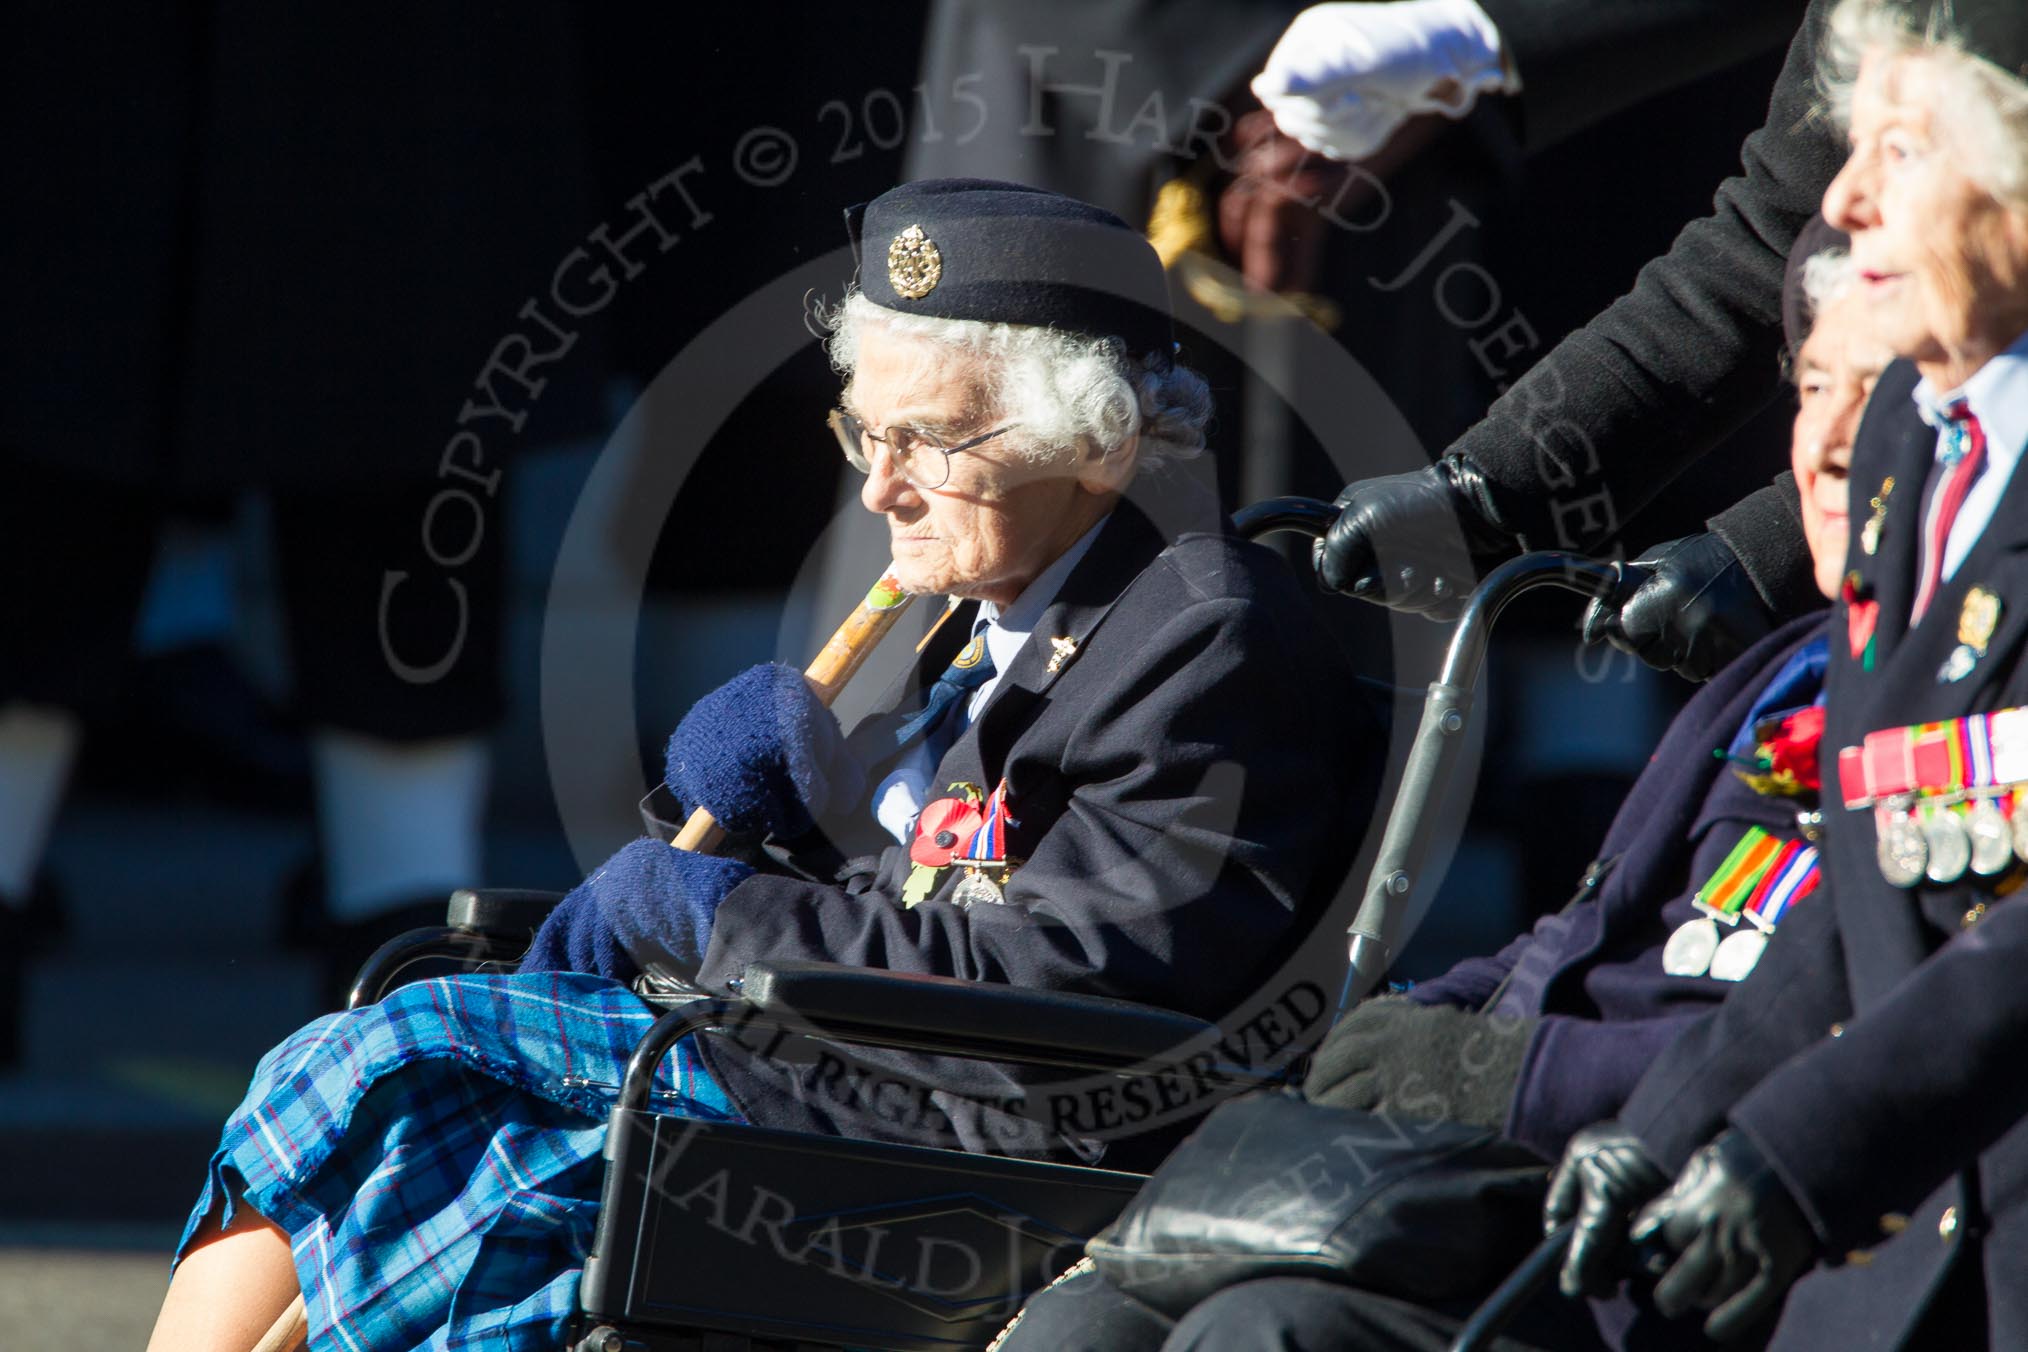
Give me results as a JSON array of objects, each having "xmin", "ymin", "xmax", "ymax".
[{"xmin": 1549, "ymin": 0, "xmax": 2028, "ymax": 1352}]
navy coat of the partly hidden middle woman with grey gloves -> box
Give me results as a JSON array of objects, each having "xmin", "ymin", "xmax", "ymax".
[{"xmin": 1409, "ymin": 614, "xmax": 1823, "ymax": 1159}]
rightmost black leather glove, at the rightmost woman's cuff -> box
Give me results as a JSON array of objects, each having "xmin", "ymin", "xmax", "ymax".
[{"xmin": 1633, "ymin": 1131, "xmax": 1817, "ymax": 1342}]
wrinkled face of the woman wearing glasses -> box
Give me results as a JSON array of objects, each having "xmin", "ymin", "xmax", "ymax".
[{"xmin": 844, "ymin": 326, "xmax": 1132, "ymax": 606}]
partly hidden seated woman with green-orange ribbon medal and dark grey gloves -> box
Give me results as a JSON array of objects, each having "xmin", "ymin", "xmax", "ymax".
[{"xmin": 1000, "ymin": 233, "xmax": 1892, "ymax": 1352}]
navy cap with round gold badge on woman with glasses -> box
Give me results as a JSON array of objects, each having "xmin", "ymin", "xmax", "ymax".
[{"xmin": 846, "ymin": 178, "xmax": 1174, "ymax": 363}]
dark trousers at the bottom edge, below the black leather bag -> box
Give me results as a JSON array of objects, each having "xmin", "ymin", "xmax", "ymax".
[{"xmin": 996, "ymin": 1271, "xmax": 1604, "ymax": 1352}]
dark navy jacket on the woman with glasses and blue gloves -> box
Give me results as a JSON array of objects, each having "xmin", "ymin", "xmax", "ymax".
[{"xmin": 700, "ymin": 472, "xmax": 1385, "ymax": 1159}]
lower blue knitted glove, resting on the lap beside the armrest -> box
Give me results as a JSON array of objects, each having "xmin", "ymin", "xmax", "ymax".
[{"xmin": 521, "ymin": 835, "xmax": 754, "ymax": 981}]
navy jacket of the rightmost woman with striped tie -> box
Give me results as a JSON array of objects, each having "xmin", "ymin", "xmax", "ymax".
[{"xmin": 1620, "ymin": 363, "xmax": 2028, "ymax": 1348}]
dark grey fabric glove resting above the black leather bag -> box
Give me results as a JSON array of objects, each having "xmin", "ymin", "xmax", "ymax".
[{"xmin": 1302, "ymin": 995, "xmax": 1535, "ymax": 1129}]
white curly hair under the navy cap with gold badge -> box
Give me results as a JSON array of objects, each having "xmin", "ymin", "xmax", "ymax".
[{"xmin": 817, "ymin": 288, "xmax": 1211, "ymax": 470}]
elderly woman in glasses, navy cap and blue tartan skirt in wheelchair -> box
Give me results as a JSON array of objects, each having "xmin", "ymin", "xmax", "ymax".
[{"xmin": 150, "ymin": 180, "xmax": 1379, "ymax": 1352}]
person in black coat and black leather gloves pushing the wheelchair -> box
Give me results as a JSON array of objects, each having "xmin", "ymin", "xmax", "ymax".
[{"xmin": 1316, "ymin": 0, "xmax": 1843, "ymax": 679}]
